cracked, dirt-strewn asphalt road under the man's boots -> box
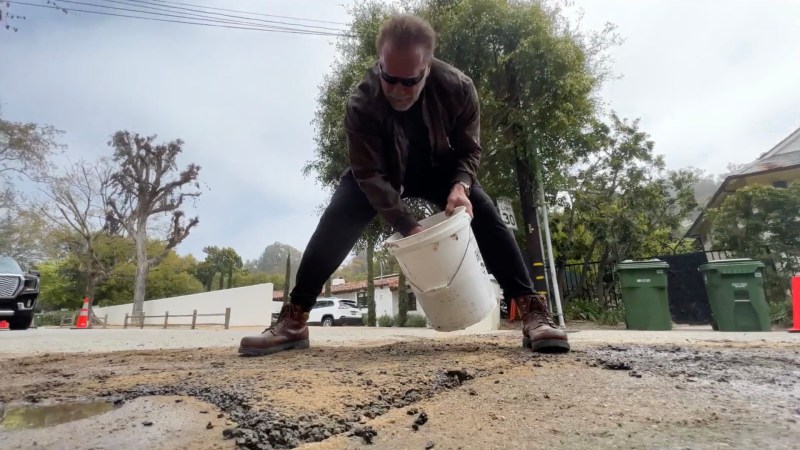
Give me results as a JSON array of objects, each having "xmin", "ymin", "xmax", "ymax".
[{"xmin": 0, "ymin": 327, "xmax": 800, "ymax": 449}]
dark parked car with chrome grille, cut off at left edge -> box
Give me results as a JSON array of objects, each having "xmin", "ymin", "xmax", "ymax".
[{"xmin": 0, "ymin": 256, "xmax": 39, "ymax": 330}]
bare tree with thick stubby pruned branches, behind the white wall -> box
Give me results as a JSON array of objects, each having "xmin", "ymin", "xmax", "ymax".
[{"xmin": 109, "ymin": 131, "xmax": 200, "ymax": 317}]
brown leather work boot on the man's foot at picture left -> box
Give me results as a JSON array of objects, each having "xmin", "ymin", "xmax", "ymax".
[{"xmin": 239, "ymin": 303, "xmax": 309, "ymax": 356}]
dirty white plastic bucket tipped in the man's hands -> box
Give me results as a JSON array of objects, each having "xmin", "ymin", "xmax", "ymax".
[{"xmin": 384, "ymin": 207, "xmax": 497, "ymax": 331}]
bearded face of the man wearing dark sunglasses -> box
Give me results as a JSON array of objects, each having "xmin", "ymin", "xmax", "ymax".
[{"xmin": 380, "ymin": 42, "xmax": 429, "ymax": 111}]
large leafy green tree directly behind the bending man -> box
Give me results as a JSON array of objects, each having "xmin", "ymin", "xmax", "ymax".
[{"xmin": 304, "ymin": 0, "xmax": 615, "ymax": 298}]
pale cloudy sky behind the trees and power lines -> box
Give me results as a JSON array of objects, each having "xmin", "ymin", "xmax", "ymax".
[{"xmin": 0, "ymin": 0, "xmax": 800, "ymax": 260}]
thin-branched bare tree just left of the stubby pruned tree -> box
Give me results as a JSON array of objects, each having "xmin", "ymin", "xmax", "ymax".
[{"xmin": 39, "ymin": 158, "xmax": 117, "ymax": 301}]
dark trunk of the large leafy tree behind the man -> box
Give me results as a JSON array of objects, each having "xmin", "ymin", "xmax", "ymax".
[{"xmin": 516, "ymin": 155, "xmax": 547, "ymax": 295}]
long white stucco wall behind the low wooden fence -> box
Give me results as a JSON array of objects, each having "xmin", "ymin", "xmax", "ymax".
[{"xmin": 92, "ymin": 283, "xmax": 282, "ymax": 327}]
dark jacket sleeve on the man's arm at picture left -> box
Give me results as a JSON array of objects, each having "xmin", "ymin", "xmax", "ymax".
[{"xmin": 345, "ymin": 99, "xmax": 418, "ymax": 236}]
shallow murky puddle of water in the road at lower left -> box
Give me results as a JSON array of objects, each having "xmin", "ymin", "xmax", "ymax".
[{"xmin": 0, "ymin": 401, "xmax": 115, "ymax": 431}]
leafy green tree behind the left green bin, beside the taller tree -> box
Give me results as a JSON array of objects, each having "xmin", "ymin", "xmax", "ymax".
[{"xmin": 554, "ymin": 115, "xmax": 698, "ymax": 301}]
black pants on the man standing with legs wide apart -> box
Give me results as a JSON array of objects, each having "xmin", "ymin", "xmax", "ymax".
[{"xmin": 291, "ymin": 171, "xmax": 534, "ymax": 311}]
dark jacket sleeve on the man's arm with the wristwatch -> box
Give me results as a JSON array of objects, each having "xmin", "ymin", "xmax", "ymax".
[{"xmin": 451, "ymin": 78, "xmax": 481, "ymax": 186}]
